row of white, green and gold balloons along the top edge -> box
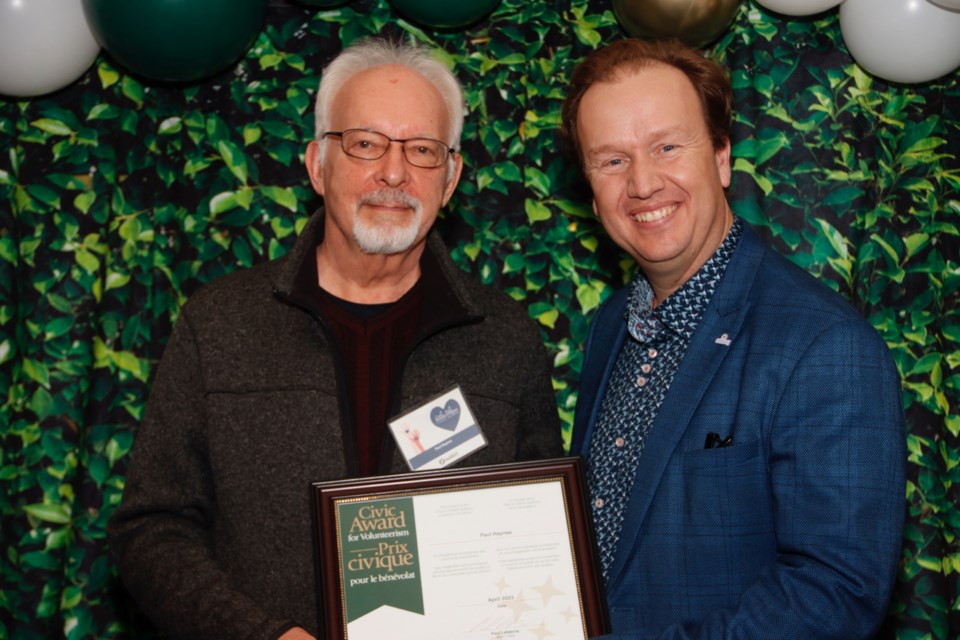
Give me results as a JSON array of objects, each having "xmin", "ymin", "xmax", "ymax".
[{"xmin": 0, "ymin": 0, "xmax": 960, "ymax": 97}]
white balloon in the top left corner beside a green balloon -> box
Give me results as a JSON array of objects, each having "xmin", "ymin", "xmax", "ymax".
[{"xmin": 0, "ymin": 0, "xmax": 100, "ymax": 96}]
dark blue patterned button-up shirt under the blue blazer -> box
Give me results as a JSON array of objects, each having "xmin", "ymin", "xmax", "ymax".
[{"xmin": 587, "ymin": 217, "xmax": 743, "ymax": 578}]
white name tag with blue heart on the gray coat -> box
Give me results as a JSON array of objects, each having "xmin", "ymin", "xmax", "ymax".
[{"xmin": 387, "ymin": 385, "xmax": 487, "ymax": 471}]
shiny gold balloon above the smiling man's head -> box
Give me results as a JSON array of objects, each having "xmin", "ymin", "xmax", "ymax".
[{"xmin": 613, "ymin": 0, "xmax": 740, "ymax": 47}]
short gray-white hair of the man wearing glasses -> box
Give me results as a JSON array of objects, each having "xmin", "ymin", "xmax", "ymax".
[{"xmin": 314, "ymin": 38, "xmax": 464, "ymax": 149}]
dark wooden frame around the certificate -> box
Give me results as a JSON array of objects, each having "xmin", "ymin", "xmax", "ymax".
[{"xmin": 310, "ymin": 456, "xmax": 610, "ymax": 640}]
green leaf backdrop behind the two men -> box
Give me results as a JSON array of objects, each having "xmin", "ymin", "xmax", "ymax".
[{"xmin": 0, "ymin": 0, "xmax": 960, "ymax": 640}]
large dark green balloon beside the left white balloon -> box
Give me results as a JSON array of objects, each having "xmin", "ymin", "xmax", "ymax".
[{"xmin": 83, "ymin": 0, "xmax": 267, "ymax": 82}]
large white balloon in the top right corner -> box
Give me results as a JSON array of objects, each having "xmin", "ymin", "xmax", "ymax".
[{"xmin": 840, "ymin": 0, "xmax": 960, "ymax": 83}]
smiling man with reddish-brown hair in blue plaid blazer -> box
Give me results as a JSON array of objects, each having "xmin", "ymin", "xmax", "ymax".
[{"xmin": 563, "ymin": 40, "xmax": 906, "ymax": 640}]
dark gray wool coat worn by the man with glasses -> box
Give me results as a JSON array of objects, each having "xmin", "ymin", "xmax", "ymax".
[{"xmin": 108, "ymin": 213, "xmax": 562, "ymax": 640}]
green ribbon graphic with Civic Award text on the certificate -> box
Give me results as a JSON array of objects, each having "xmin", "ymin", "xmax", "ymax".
[{"xmin": 337, "ymin": 498, "xmax": 423, "ymax": 622}]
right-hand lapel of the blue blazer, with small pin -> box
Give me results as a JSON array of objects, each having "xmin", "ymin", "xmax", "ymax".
[{"xmin": 597, "ymin": 226, "xmax": 765, "ymax": 584}]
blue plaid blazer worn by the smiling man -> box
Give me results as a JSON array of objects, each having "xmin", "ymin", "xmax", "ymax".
[{"xmin": 571, "ymin": 228, "xmax": 906, "ymax": 640}]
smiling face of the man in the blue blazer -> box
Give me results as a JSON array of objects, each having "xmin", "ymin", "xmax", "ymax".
[{"xmin": 577, "ymin": 64, "xmax": 732, "ymax": 290}]
